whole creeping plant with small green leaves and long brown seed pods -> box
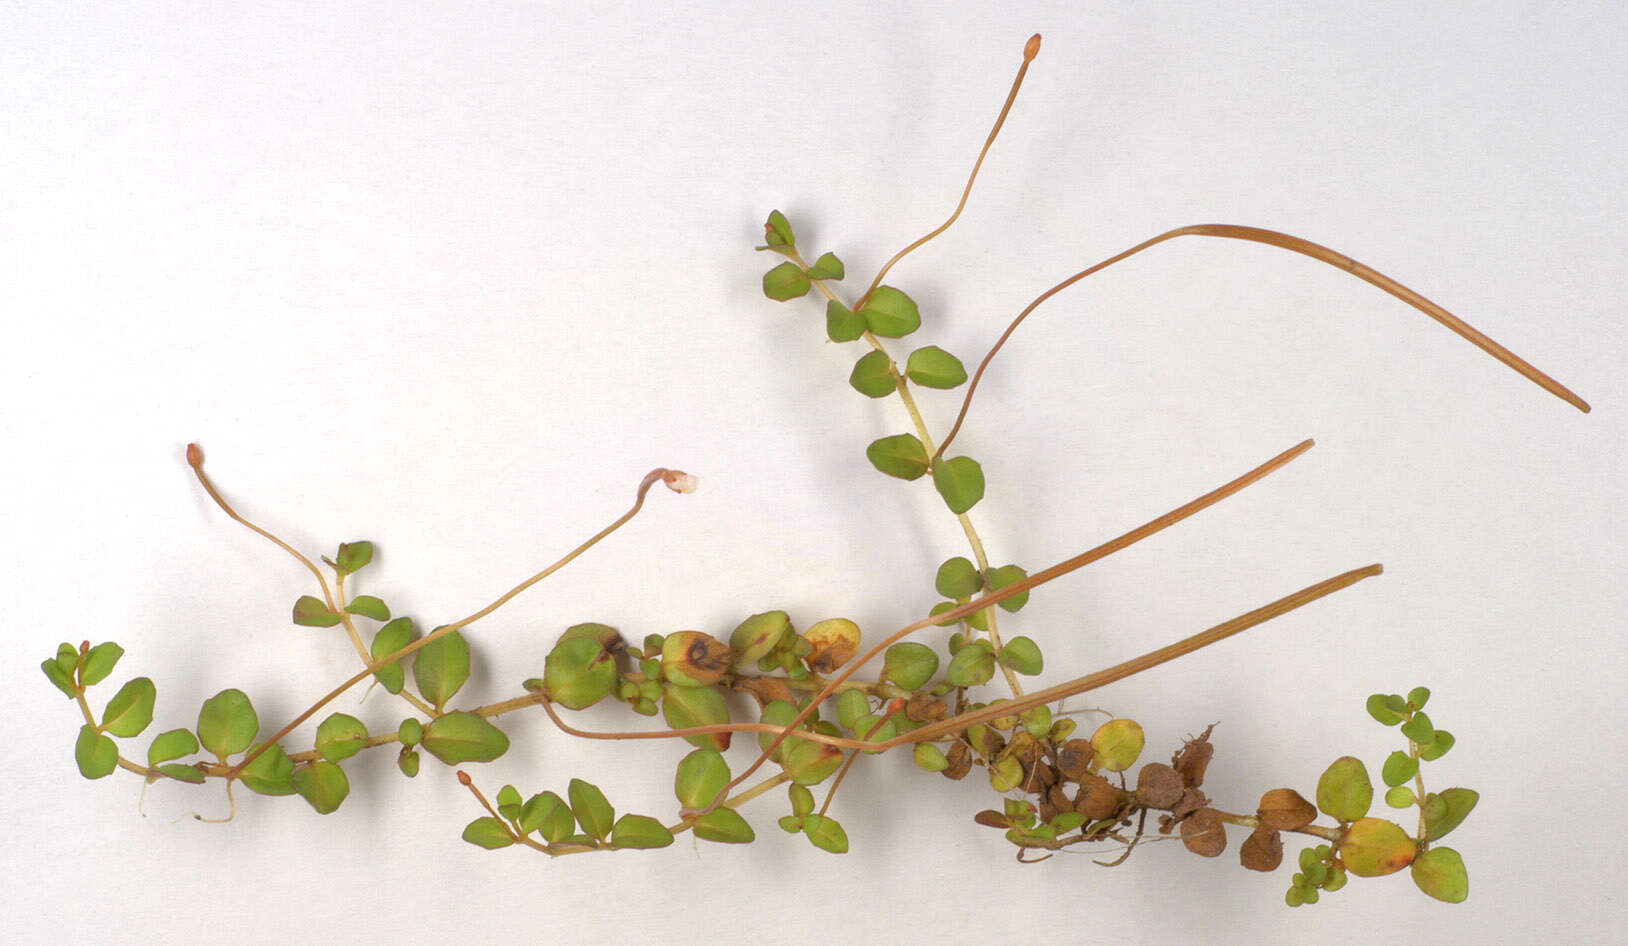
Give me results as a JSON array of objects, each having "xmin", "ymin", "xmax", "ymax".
[{"xmin": 41, "ymin": 37, "xmax": 1587, "ymax": 905}]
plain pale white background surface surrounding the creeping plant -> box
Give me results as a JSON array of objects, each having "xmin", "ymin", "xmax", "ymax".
[{"xmin": 0, "ymin": 0, "xmax": 1628, "ymax": 943}]
